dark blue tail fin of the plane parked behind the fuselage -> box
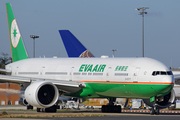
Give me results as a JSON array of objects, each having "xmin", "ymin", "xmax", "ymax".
[{"xmin": 59, "ymin": 30, "xmax": 94, "ymax": 57}]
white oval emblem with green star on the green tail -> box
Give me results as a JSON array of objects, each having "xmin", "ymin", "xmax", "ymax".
[{"xmin": 11, "ymin": 19, "xmax": 21, "ymax": 48}]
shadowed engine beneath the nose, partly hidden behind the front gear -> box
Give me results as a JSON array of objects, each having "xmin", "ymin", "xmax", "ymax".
[{"xmin": 143, "ymin": 89, "xmax": 175, "ymax": 109}]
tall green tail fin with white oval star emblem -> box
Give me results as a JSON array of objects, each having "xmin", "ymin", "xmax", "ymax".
[{"xmin": 6, "ymin": 3, "xmax": 28, "ymax": 62}]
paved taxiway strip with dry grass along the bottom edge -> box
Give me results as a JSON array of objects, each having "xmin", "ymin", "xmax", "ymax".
[{"xmin": 0, "ymin": 110, "xmax": 180, "ymax": 120}]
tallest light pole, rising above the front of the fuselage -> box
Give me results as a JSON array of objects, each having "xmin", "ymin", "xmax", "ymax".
[{"xmin": 135, "ymin": 7, "xmax": 149, "ymax": 57}]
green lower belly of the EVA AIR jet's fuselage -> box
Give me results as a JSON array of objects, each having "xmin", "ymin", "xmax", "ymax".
[{"xmin": 67, "ymin": 83, "xmax": 173, "ymax": 99}]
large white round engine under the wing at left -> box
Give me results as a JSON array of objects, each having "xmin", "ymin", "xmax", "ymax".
[{"xmin": 25, "ymin": 81, "xmax": 59, "ymax": 108}]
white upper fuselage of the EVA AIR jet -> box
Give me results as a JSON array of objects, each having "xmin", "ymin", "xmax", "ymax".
[{"xmin": 6, "ymin": 58, "xmax": 174, "ymax": 83}]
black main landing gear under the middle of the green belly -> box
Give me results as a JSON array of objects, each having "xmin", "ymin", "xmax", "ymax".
[{"xmin": 101, "ymin": 98, "xmax": 121, "ymax": 113}]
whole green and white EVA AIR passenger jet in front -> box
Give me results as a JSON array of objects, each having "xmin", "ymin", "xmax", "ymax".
[{"xmin": 0, "ymin": 3, "xmax": 175, "ymax": 114}]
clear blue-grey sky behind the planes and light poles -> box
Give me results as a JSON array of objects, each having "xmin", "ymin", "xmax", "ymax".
[{"xmin": 0, "ymin": 0, "xmax": 180, "ymax": 68}]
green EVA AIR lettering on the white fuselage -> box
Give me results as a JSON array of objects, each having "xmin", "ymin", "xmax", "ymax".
[{"xmin": 79, "ymin": 64, "xmax": 106, "ymax": 72}]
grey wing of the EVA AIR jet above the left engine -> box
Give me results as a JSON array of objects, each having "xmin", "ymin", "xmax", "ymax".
[{"xmin": 0, "ymin": 75, "xmax": 86, "ymax": 93}]
